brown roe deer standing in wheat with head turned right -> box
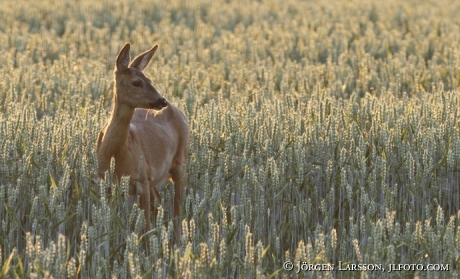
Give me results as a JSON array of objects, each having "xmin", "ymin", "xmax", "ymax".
[{"xmin": 96, "ymin": 43, "xmax": 189, "ymax": 243}]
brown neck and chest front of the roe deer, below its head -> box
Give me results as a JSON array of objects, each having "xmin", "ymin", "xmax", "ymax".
[{"xmin": 102, "ymin": 97, "xmax": 134, "ymax": 157}]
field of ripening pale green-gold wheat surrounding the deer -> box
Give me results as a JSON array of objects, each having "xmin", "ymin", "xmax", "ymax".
[{"xmin": 0, "ymin": 0, "xmax": 460, "ymax": 278}]
